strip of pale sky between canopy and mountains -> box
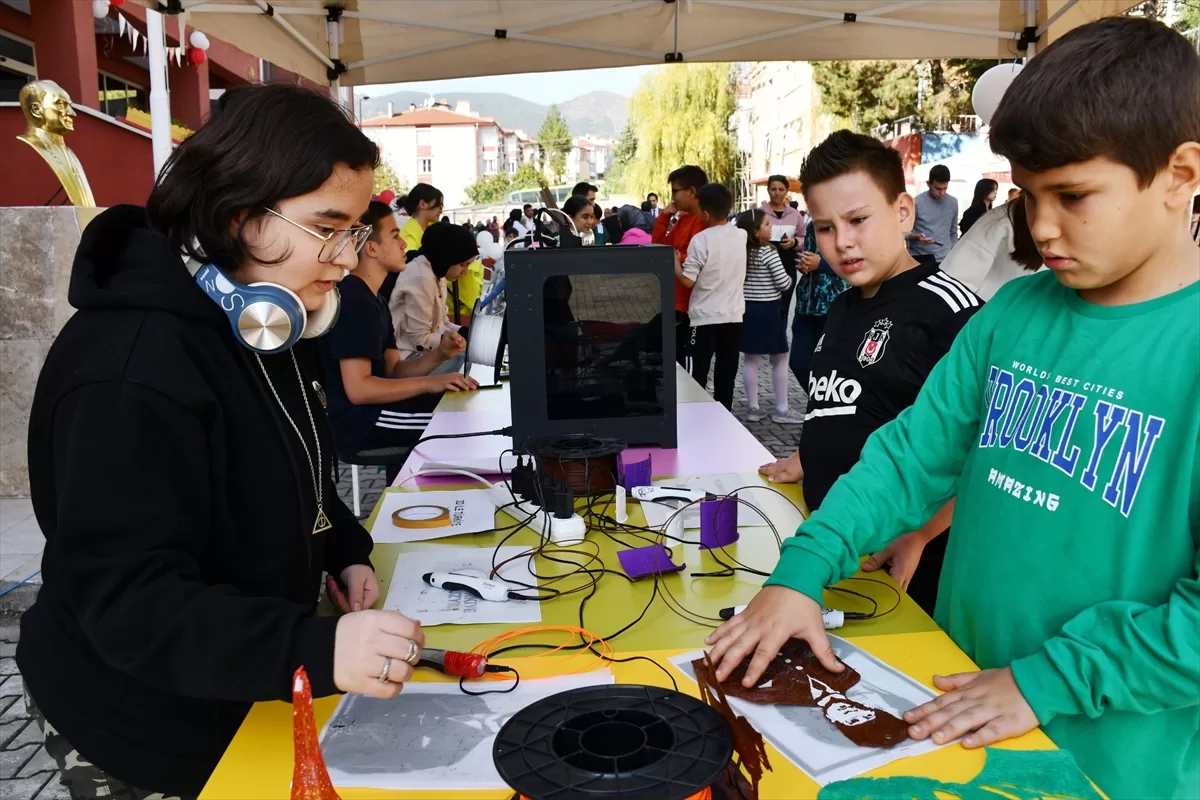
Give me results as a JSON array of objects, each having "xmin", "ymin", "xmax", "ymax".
[{"xmin": 355, "ymin": 66, "xmax": 654, "ymax": 103}]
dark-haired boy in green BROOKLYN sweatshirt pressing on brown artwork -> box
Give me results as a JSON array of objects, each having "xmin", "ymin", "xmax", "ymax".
[{"xmin": 708, "ymin": 17, "xmax": 1200, "ymax": 798}]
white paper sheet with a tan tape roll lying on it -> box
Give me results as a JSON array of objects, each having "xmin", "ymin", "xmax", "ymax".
[{"xmin": 371, "ymin": 488, "xmax": 496, "ymax": 543}]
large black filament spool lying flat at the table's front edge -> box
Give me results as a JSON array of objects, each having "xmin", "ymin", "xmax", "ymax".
[{"xmin": 492, "ymin": 684, "xmax": 733, "ymax": 800}]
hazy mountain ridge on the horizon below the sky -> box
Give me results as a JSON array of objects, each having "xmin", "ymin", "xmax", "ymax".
[{"xmin": 362, "ymin": 91, "xmax": 629, "ymax": 139}]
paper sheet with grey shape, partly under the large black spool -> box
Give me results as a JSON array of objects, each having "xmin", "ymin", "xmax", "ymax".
[{"xmin": 320, "ymin": 669, "xmax": 613, "ymax": 790}]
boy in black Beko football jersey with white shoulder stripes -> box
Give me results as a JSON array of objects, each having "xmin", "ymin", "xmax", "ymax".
[{"xmin": 760, "ymin": 131, "xmax": 983, "ymax": 614}]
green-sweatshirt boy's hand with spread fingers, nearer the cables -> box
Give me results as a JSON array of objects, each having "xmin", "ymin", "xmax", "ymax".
[{"xmin": 704, "ymin": 587, "xmax": 845, "ymax": 688}]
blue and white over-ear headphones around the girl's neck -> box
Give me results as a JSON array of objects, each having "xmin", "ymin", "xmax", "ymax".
[{"xmin": 187, "ymin": 259, "xmax": 342, "ymax": 354}]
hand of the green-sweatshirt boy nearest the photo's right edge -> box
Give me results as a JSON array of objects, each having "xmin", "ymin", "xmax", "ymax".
[{"xmin": 904, "ymin": 667, "xmax": 1038, "ymax": 748}]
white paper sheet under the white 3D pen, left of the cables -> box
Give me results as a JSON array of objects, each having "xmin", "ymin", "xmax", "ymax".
[{"xmin": 383, "ymin": 545, "xmax": 541, "ymax": 627}]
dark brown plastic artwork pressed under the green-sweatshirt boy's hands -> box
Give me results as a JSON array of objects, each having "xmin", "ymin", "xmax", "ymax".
[{"xmin": 691, "ymin": 639, "xmax": 908, "ymax": 747}]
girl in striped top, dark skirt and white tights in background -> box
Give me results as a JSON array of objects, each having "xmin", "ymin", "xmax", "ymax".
[{"xmin": 737, "ymin": 209, "xmax": 804, "ymax": 425}]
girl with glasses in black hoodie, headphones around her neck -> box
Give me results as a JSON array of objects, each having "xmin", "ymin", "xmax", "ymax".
[{"xmin": 17, "ymin": 84, "xmax": 424, "ymax": 799}]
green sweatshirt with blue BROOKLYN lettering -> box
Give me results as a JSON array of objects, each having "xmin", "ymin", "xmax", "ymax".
[{"xmin": 767, "ymin": 272, "xmax": 1200, "ymax": 800}]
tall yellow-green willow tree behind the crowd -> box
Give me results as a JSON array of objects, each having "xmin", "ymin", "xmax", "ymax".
[{"xmin": 623, "ymin": 64, "xmax": 737, "ymax": 196}]
